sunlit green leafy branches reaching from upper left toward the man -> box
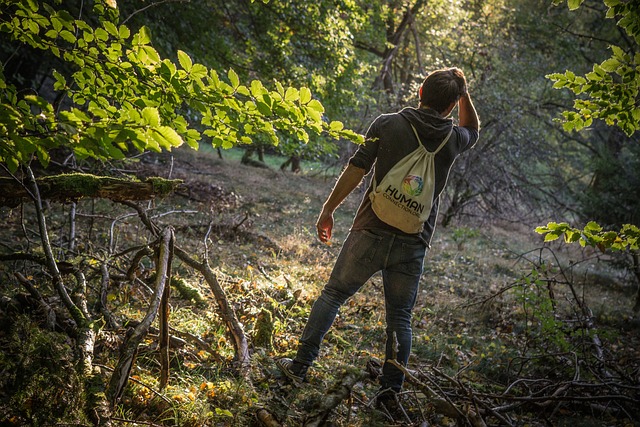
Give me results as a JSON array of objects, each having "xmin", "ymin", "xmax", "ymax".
[{"xmin": 0, "ymin": 0, "xmax": 362, "ymax": 171}]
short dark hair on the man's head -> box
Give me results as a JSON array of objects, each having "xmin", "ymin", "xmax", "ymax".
[{"xmin": 420, "ymin": 68, "xmax": 467, "ymax": 113}]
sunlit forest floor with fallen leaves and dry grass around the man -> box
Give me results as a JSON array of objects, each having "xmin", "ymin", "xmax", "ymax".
[{"xmin": 0, "ymin": 145, "xmax": 640, "ymax": 426}]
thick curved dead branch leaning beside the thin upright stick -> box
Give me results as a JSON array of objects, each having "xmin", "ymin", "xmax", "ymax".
[{"xmin": 106, "ymin": 227, "xmax": 174, "ymax": 406}]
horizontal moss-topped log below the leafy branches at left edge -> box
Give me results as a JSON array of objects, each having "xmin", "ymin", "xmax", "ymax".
[{"xmin": 0, "ymin": 173, "xmax": 182, "ymax": 207}]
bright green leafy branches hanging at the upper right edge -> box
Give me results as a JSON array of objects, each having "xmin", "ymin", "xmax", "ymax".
[{"xmin": 547, "ymin": 0, "xmax": 640, "ymax": 136}]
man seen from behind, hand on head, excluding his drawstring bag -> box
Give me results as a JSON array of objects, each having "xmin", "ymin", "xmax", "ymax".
[{"xmin": 277, "ymin": 68, "xmax": 479, "ymax": 404}]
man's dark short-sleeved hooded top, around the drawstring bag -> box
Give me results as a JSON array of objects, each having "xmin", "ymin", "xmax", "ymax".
[{"xmin": 349, "ymin": 107, "xmax": 478, "ymax": 247}]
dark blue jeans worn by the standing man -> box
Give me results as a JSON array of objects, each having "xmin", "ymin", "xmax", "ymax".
[{"xmin": 295, "ymin": 230, "xmax": 426, "ymax": 391}]
